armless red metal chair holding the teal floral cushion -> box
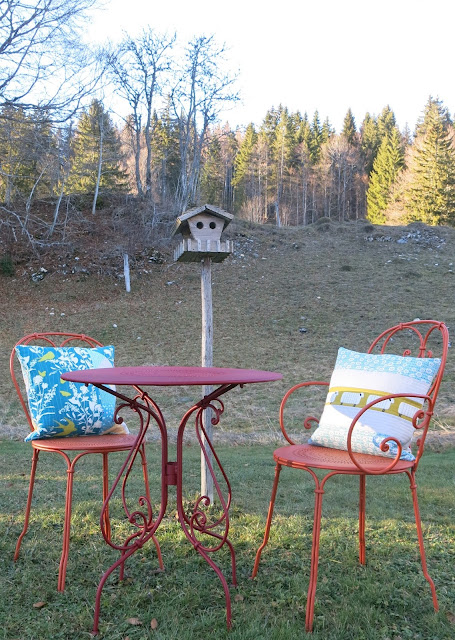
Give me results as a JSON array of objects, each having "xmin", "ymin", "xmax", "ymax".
[{"xmin": 10, "ymin": 332, "xmax": 164, "ymax": 591}]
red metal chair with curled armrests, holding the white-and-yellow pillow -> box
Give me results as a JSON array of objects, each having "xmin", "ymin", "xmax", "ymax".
[{"xmin": 252, "ymin": 320, "xmax": 449, "ymax": 631}]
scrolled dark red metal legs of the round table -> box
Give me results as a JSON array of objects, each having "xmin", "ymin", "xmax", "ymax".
[{"xmin": 92, "ymin": 384, "xmax": 237, "ymax": 635}]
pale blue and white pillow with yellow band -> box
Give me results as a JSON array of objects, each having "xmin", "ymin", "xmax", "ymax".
[{"xmin": 309, "ymin": 347, "xmax": 441, "ymax": 461}]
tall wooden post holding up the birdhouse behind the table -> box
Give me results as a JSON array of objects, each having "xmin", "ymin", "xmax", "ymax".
[{"xmin": 201, "ymin": 257, "xmax": 213, "ymax": 504}]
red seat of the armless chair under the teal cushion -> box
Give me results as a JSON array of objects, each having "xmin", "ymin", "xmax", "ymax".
[{"xmin": 31, "ymin": 433, "xmax": 137, "ymax": 452}]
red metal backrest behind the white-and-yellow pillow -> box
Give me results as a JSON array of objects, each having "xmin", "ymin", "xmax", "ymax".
[{"xmin": 368, "ymin": 320, "xmax": 449, "ymax": 461}]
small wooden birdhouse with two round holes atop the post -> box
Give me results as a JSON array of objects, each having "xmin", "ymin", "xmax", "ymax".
[{"xmin": 172, "ymin": 204, "xmax": 234, "ymax": 262}]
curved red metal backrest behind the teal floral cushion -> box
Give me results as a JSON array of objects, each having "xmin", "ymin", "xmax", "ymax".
[{"xmin": 9, "ymin": 331, "xmax": 103, "ymax": 431}]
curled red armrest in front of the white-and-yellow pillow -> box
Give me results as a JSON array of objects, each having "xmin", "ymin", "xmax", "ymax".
[{"xmin": 347, "ymin": 393, "xmax": 433, "ymax": 475}]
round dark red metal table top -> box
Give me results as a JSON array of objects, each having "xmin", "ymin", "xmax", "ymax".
[{"xmin": 61, "ymin": 367, "xmax": 283, "ymax": 387}]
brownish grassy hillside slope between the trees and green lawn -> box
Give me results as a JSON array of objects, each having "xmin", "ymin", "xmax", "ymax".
[{"xmin": 0, "ymin": 219, "xmax": 455, "ymax": 441}]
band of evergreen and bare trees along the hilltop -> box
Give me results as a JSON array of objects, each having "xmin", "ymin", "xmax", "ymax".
[{"xmin": 0, "ymin": 0, "xmax": 455, "ymax": 258}]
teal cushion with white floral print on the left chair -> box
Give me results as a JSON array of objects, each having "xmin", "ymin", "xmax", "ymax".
[{"xmin": 16, "ymin": 345, "xmax": 115, "ymax": 441}]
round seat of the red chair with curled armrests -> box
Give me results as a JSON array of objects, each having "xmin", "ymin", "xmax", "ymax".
[{"xmin": 273, "ymin": 444, "xmax": 414, "ymax": 474}]
